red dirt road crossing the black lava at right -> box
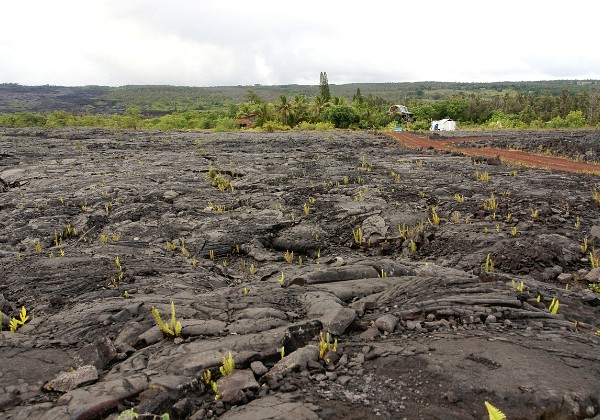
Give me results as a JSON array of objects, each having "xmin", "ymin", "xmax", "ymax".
[{"xmin": 391, "ymin": 132, "xmax": 600, "ymax": 174}]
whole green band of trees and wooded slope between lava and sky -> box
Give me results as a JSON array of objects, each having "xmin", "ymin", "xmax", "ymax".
[{"xmin": 0, "ymin": 81, "xmax": 600, "ymax": 130}]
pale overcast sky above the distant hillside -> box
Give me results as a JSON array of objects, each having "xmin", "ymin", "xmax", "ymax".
[{"xmin": 0, "ymin": 0, "xmax": 600, "ymax": 86}]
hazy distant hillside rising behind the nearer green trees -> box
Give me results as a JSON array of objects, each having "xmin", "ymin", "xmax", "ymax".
[{"xmin": 0, "ymin": 80, "xmax": 600, "ymax": 115}]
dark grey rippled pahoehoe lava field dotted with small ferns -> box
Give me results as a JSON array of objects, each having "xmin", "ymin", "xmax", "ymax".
[{"xmin": 0, "ymin": 128, "xmax": 600, "ymax": 419}]
